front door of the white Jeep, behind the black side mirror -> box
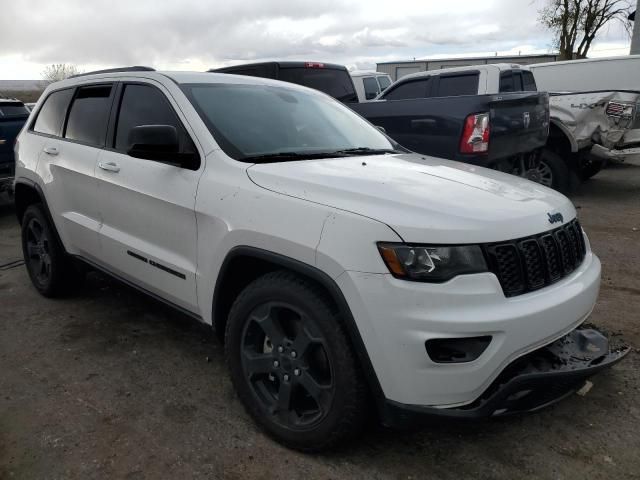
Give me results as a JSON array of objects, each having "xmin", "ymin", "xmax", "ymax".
[{"xmin": 96, "ymin": 82, "xmax": 203, "ymax": 312}]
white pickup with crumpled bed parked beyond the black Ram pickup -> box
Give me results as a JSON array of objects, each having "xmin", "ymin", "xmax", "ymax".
[{"xmin": 390, "ymin": 64, "xmax": 640, "ymax": 192}]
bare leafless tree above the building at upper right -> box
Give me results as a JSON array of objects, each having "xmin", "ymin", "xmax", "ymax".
[{"xmin": 538, "ymin": 0, "xmax": 631, "ymax": 60}]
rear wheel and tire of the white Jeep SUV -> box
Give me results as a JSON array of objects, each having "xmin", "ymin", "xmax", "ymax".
[{"xmin": 22, "ymin": 204, "xmax": 75, "ymax": 297}]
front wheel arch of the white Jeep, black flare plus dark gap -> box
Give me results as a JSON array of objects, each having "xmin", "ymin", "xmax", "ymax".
[{"xmin": 212, "ymin": 246, "xmax": 384, "ymax": 406}]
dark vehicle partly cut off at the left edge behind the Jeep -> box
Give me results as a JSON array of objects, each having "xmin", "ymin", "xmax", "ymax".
[{"xmin": 0, "ymin": 98, "xmax": 29, "ymax": 193}]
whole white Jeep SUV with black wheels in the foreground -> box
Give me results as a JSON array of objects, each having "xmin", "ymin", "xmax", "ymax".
[{"xmin": 15, "ymin": 67, "xmax": 627, "ymax": 451}]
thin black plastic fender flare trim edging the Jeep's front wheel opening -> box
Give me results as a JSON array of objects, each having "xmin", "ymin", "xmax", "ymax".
[{"xmin": 212, "ymin": 246, "xmax": 385, "ymax": 408}]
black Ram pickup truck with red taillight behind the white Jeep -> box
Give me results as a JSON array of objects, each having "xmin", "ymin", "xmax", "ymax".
[{"xmin": 209, "ymin": 62, "xmax": 554, "ymax": 186}]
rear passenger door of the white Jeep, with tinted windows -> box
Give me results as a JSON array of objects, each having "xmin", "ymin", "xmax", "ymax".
[{"xmin": 33, "ymin": 83, "xmax": 115, "ymax": 260}]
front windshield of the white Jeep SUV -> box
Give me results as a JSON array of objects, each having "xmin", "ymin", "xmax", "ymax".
[{"xmin": 182, "ymin": 84, "xmax": 395, "ymax": 161}]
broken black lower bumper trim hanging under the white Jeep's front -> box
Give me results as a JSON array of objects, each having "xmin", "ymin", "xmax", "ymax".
[{"xmin": 382, "ymin": 328, "xmax": 630, "ymax": 428}]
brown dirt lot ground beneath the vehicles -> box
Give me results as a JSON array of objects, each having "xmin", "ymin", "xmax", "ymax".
[{"xmin": 0, "ymin": 166, "xmax": 640, "ymax": 480}]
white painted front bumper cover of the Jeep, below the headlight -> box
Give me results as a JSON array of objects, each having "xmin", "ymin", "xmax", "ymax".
[{"xmin": 336, "ymin": 251, "xmax": 600, "ymax": 409}]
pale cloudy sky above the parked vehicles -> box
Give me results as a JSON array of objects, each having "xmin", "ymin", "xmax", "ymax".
[{"xmin": 0, "ymin": 0, "xmax": 630, "ymax": 80}]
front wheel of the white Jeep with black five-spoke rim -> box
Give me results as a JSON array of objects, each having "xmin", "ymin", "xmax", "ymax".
[{"xmin": 225, "ymin": 271, "xmax": 368, "ymax": 452}]
